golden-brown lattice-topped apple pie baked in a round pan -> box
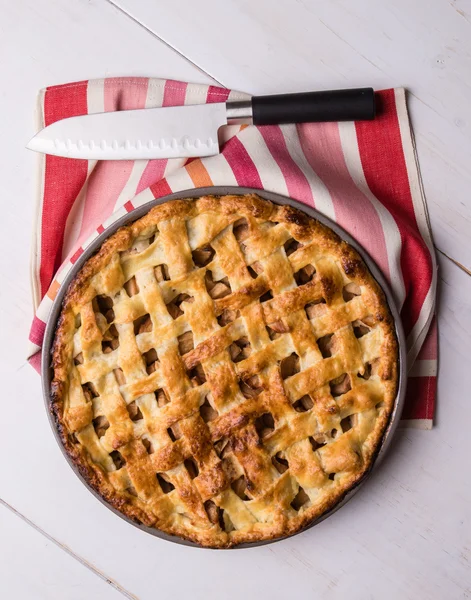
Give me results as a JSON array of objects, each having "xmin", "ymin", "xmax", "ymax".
[{"xmin": 51, "ymin": 195, "xmax": 398, "ymax": 547}]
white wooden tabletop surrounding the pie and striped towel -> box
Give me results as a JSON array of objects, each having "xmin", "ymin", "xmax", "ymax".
[{"xmin": 0, "ymin": 0, "xmax": 471, "ymax": 600}]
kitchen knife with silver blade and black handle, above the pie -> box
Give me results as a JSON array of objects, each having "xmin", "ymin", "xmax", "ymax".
[{"xmin": 27, "ymin": 88, "xmax": 375, "ymax": 160}]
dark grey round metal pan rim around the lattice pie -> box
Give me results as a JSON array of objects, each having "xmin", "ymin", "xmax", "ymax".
[{"xmin": 41, "ymin": 186, "xmax": 407, "ymax": 549}]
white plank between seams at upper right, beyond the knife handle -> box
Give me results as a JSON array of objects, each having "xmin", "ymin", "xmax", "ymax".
[{"xmin": 110, "ymin": 0, "xmax": 471, "ymax": 268}]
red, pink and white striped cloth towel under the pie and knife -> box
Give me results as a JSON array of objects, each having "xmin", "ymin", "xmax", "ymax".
[{"xmin": 29, "ymin": 78, "xmax": 437, "ymax": 428}]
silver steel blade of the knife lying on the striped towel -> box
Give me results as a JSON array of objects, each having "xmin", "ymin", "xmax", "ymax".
[{"xmin": 27, "ymin": 103, "xmax": 227, "ymax": 160}]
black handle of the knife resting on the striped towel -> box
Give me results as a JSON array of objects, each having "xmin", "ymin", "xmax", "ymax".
[{"xmin": 252, "ymin": 88, "xmax": 375, "ymax": 125}]
